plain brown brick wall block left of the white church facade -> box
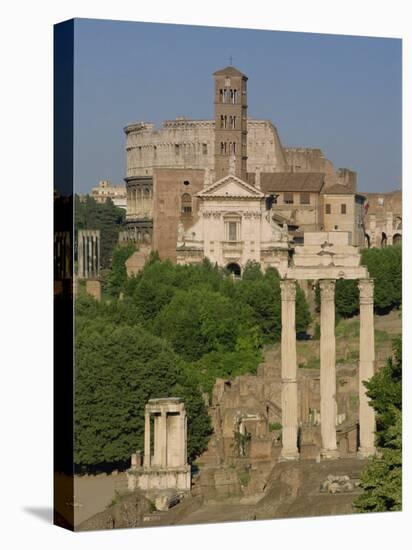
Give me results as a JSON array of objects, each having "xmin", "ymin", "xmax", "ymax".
[{"xmin": 152, "ymin": 168, "xmax": 205, "ymax": 262}]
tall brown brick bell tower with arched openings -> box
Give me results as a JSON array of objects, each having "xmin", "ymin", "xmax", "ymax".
[{"xmin": 213, "ymin": 66, "xmax": 247, "ymax": 180}]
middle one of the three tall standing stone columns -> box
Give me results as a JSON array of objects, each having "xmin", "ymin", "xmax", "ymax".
[{"xmin": 319, "ymin": 279, "xmax": 339, "ymax": 459}]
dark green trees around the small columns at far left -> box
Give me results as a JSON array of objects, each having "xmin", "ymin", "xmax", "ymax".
[{"xmin": 74, "ymin": 195, "xmax": 126, "ymax": 269}]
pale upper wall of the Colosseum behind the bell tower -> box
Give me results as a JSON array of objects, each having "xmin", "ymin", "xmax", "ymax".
[{"xmin": 125, "ymin": 119, "xmax": 287, "ymax": 183}]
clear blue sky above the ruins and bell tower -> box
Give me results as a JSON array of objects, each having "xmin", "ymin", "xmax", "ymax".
[{"xmin": 75, "ymin": 19, "xmax": 402, "ymax": 193}]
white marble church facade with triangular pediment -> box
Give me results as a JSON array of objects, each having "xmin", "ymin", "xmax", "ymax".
[{"xmin": 177, "ymin": 174, "xmax": 288, "ymax": 275}]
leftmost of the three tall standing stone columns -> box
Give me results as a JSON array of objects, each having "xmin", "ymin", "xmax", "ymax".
[{"xmin": 280, "ymin": 280, "xmax": 299, "ymax": 460}]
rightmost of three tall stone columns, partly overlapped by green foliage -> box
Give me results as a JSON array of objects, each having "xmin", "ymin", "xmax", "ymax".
[{"xmin": 358, "ymin": 279, "xmax": 376, "ymax": 458}]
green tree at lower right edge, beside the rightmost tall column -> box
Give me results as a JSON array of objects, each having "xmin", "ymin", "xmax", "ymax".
[{"xmin": 355, "ymin": 339, "xmax": 402, "ymax": 512}]
